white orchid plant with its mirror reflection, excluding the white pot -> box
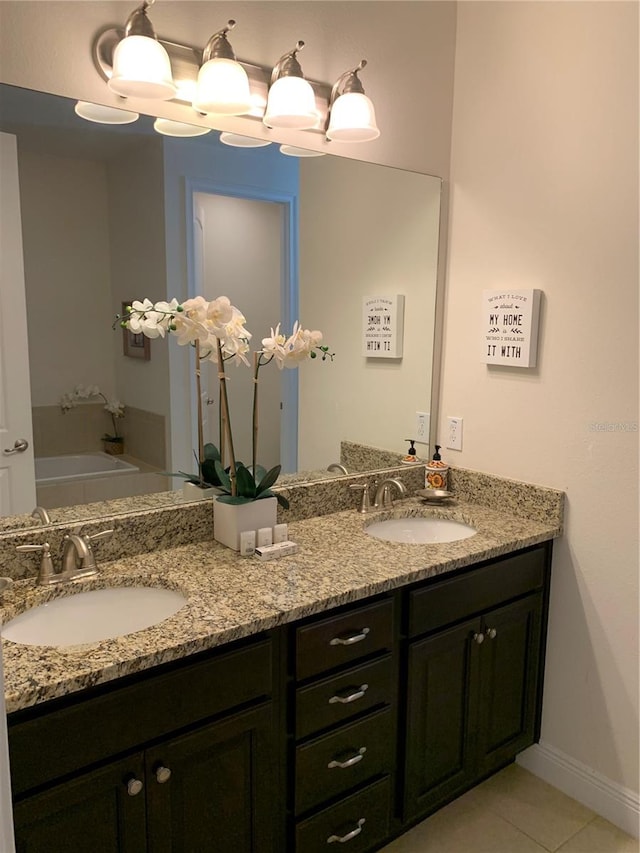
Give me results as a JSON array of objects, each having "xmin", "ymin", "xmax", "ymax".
[{"xmin": 116, "ymin": 296, "xmax": 334, "ymax": 508}]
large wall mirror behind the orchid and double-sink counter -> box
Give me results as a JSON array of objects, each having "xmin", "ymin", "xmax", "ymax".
[{"xmin": 0, "ymin": 86, "xmax": 441, "ymax": 528}]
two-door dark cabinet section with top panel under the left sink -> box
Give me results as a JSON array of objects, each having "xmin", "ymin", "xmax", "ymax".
[{"xmin": 10, "ymin": 641, "xmax": 282, "ymax": 853}]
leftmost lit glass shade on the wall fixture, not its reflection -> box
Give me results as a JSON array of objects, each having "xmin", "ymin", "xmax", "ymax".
[{"xmin": 108, "ymin": 36, "xmax": 177, "ymax": 101}]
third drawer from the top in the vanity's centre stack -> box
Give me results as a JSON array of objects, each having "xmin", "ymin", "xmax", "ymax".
[{"xmin": 296, "ymin": 709, "xmax": 394, "ymax": 814}]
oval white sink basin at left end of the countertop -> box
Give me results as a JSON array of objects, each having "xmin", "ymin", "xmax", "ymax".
[{"xmin": 1, "ymin": 586, "xmax": 187, "ymax": 646}]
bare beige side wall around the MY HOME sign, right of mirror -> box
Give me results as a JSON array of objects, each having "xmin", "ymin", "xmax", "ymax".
[{"xmin": 440, "ymin": 2, "xmax": 638, "ymax": 819}]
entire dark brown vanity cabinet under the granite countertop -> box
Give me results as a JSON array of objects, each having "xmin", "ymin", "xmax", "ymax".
[{"xmin": 9, "ymin": 543, "xmax": 551, "ymax": 853}]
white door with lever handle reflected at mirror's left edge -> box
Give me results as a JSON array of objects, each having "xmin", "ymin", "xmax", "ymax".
[{"xmin": 0, "ymin": 133, "xmax": 36, "ymax": 516}]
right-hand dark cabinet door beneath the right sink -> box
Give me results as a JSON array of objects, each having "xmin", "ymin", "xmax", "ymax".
[{"xmin": 477, "ymin": 595, "xmax": 542, "ymax": 776}]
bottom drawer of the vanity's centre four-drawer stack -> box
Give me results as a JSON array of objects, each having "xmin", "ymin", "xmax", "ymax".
[{"xmin": 296, "ymin": 777, "xmax": 391, "ymax": 853}]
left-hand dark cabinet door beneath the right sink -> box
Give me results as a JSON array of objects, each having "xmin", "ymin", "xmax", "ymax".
[{"xmin": 404, "ymin": 619, "xmax": 481, "ymax": 820}]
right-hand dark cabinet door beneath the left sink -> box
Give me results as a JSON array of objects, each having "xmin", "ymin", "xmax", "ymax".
[{"xmin": 146, "ymin": 704, "xmax": 279, "ymax": 853}]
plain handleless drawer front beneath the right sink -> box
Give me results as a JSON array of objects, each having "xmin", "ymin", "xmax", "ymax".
[{"xmin": 409, "ymin": 548, "xmax": 547, "ymax": 637}]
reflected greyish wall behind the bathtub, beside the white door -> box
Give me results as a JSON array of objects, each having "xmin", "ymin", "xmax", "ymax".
[{"xmin": 18, "ymin": 151, "xmax": 115, "ymax": 406}]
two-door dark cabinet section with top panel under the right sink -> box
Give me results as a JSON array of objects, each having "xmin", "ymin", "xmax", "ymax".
[{"xmin": 402, "ymin": 550, "xmax": 546, "ymax": 821}]
